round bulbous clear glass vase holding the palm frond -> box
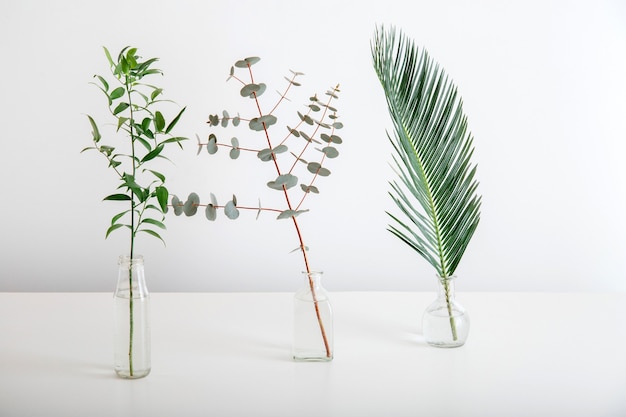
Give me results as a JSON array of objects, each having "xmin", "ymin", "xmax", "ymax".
[{"xmin": 422, "ymin": 276, "xmax": 470, "ymax": 348}]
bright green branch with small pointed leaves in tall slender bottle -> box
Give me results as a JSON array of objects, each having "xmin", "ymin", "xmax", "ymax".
[{"xmin": 81, "ymin": 47, "xmax": 186, "ymax": 377}]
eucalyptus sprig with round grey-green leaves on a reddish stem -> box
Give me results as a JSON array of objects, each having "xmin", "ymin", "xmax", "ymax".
[{"xmin": 172, "ymin": 57, "xmax": 343, "ymax": 357}]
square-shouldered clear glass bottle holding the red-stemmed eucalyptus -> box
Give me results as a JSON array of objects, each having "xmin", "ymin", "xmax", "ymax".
[{"xmin": 293, "ymin": 272, "xmax": 333, "ymax": 362}]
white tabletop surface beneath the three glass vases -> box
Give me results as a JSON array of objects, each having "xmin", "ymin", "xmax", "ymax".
[{"xmin": 0, "ymin": 292, "xmax": 626, "ymax": 417}]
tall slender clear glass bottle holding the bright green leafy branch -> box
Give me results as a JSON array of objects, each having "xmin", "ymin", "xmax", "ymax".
[{"xmin": 113, "ymin": 255, "xmax": 151, "ymax": 379}]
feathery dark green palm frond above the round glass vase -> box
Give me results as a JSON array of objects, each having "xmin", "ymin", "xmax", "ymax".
[{"xmin": 371, "ymin": 28, "xmax": 481, "ymax": 277}]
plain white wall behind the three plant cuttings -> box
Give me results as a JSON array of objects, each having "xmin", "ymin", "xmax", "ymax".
[{"xmin": 0, "ymin": 0, "xmax": 626, "ymax": 291}]
